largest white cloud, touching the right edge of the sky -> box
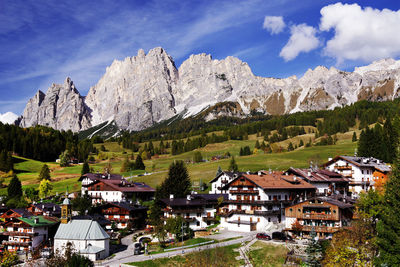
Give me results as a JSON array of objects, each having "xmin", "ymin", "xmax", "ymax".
[{"xmin": 319, "ymin": 3, "xmax": 400, "ymax": 64}]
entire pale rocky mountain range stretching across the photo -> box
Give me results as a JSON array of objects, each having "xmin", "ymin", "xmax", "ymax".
[{"xmin": 20, "ymin": 47, "xmax": 400, "ymax": 131}]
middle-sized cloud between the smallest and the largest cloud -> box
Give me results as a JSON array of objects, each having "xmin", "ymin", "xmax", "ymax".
[{"xmin": 279, "ymin": 23, "xmax": 319, "ymax": 61}]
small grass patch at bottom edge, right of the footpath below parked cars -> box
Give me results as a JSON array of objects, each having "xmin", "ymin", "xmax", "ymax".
[{"xmin": 248, "ymin": 241, "xmax": 288, "ymax": 267}]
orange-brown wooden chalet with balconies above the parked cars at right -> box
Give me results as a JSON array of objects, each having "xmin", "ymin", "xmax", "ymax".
[{"xmin": 285, "ymin": 196, "xmax": 354, "ymax": 238}]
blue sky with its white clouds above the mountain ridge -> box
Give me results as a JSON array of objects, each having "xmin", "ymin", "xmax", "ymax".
[{"xmin": 0, "ymin": 0, "xmax": 400, "ymax": 115}]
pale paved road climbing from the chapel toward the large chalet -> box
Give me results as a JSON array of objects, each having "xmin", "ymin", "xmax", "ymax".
[{"xmin": 96, "ymin": 233, "xmax": 255, "ymax": 267}]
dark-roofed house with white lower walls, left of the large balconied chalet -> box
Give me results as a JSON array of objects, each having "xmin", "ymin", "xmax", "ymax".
[{"xmin": 161, "ymin": 194, "xmax": 227, "ymax": 231}]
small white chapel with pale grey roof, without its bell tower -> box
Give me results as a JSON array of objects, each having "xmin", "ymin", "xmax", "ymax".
[{"xmin": 54, "ymin": 220, "xmax": 110, "ymax": 261}]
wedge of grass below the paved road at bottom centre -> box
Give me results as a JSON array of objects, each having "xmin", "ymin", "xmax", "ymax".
[{"xmin": 128, "ymin": 244, "xmax": 243, "ymax": 267}]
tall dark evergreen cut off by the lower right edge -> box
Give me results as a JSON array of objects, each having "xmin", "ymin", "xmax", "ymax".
[{"xmin": 376, "ymin": 159, "xmax": 400, "ymax": 266}]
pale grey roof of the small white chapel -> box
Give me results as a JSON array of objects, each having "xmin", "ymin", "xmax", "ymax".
[{"xmin": 54, "ymin": 220, "xmax": 110, "ymax": 240}]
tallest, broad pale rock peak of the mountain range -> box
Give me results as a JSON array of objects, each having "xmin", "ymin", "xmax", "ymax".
[{"xmin": 86, "ymin": 48, "xmax": 179, "ymax": 130}]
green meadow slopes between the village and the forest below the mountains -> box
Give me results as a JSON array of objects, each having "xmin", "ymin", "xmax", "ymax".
[{"xmin": 0, "ymin": 129, "xmax": 357, "ymax": 194}]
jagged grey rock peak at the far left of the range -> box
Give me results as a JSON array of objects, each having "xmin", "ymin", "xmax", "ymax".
[{"xmin": 20, "ymin": 77, "xmax": 91, "ymax": 132}]
